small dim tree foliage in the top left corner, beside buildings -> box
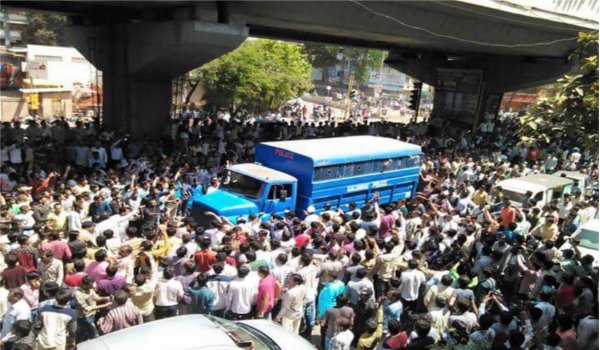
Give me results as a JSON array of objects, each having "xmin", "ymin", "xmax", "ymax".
[{"xmin": 22, "ymin": 12, "xmax": 67, "ymax": 46}]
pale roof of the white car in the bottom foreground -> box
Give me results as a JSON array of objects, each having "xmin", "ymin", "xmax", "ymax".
[{"xmin": 77, "ymin": 315, "xmax": 236, "ymax": 350}]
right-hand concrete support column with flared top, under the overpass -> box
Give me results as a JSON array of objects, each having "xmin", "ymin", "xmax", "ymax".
[{"xmin": 386, "ymin": 51, "xmax": 573, "ymax": 130}]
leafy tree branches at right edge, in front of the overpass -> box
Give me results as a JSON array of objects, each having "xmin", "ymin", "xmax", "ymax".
[{"xmin": 517, "ymin": 32, "xmax": 598, "ymax": 151}]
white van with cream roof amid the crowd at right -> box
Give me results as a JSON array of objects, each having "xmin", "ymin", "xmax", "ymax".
[{"xmin": 498, "ymin": 174, "xmax": 574, "ymax": 208}]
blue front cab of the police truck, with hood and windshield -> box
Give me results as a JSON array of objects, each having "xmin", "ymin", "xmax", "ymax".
[{"xmin": 192, "ymin": 163, "xmax": 298, "ymax": 225}]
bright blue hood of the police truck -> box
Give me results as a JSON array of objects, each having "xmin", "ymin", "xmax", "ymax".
[{"xmin": 195, "ymin": 190, "xmax": 258, "ymax": 216}]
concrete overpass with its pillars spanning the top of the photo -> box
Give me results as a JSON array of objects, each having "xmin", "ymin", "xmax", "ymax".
[{"xmin": 3, "ymin": 0, "xmax": 598, "ymax": 135}]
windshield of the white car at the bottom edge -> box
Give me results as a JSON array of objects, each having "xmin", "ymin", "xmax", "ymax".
[{"xmin": 208, "ymin": 316, "xmax": 279, "ymax": 350}]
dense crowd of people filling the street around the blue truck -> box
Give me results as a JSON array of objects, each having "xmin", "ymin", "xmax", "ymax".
[{"xmin": 0, "ymin": 110, "xmax": 599, "ymax": 350}]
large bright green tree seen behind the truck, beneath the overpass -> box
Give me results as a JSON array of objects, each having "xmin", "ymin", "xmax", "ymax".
[{"xmin": 201, "ymin": 39, "xmax": 312, "ymax": 111}]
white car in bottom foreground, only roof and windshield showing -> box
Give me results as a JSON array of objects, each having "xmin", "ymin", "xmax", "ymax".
[{"xmin": 77, "ymin": 314, "xmax": 316, "ymax": 350}]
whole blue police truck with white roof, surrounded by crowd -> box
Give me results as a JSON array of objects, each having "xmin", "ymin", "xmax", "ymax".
[{"xmin": 192, "ymin": 136, "xmax": 421, "ymax": 223}]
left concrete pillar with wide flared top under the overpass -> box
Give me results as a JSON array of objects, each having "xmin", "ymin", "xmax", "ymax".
[{"xmin": 67, "ymin": 19, "xmax": 248, "ymax": 137}]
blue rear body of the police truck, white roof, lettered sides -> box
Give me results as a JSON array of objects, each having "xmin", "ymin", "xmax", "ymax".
[{"xmin": 255, "ymin": 136, "xmax": 422, "ymax": 215}]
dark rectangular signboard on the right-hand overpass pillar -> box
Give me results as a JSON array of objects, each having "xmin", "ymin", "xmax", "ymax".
[{"xmin": 433, "ymin": 68, "xmax": 483, "ymax": 125}]
